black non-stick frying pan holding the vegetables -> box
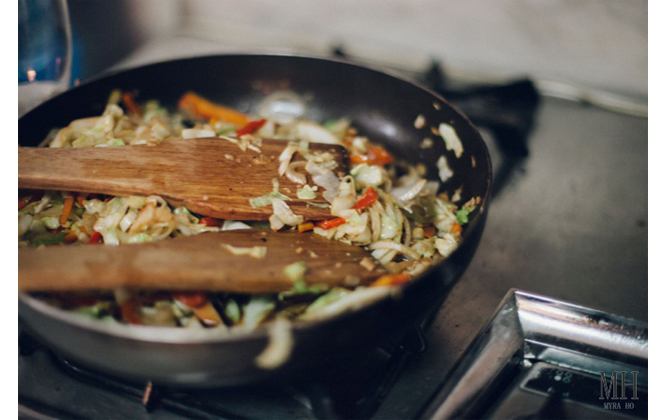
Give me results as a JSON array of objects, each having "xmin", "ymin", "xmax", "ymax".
[{"xmin": 19, "ymin": 55, "xmax": 491, "ymax": 387}]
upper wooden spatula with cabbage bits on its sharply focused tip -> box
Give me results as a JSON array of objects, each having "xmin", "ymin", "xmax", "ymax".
[{"xmin": 18, "ymin": 138, "xmax": 348, "ymax": 220}]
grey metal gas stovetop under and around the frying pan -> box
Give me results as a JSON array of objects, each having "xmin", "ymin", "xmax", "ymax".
[{"xmin": 18, "ymin": 40, "xmax": 648, "ymax": 419}]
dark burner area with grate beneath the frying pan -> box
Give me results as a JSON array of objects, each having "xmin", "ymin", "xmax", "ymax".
[{"xmin": 19, "ymin": 328, "xmax": 424, "ymax": 419}]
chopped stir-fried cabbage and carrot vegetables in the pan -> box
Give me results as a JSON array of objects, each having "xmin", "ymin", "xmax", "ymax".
[{"xmin": 18, "ymin": 91, "xmax": 479, "ymax": 330}]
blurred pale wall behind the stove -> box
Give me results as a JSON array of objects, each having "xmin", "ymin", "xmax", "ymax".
[{"xmin": 65, "ymin": 0, "xmax": 648, "ymax": 100}]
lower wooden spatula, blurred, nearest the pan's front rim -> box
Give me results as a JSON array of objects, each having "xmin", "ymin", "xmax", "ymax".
[{"xmin": 18, "ymin": 230, "xmax": 385, "ymax": 293}]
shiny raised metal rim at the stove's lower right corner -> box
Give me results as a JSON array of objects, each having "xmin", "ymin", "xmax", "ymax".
[{"xmin": 417, "ymin": 289, "xmax": 648, "ymax": 420}]
